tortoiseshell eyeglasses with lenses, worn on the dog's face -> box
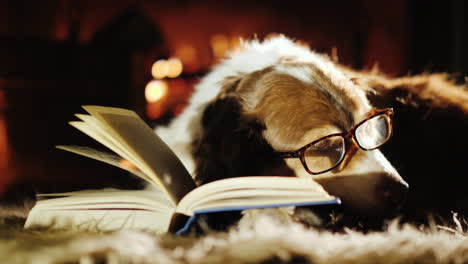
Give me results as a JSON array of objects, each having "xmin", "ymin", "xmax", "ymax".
[{"xmin": 277, "ymin": 108, "xmax": 393, "ymax": 175}]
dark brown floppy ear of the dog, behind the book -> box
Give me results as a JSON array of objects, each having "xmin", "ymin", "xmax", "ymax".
[{"xmin": 193, "ymin": 77, "xmax": 290, "ymax": 184}]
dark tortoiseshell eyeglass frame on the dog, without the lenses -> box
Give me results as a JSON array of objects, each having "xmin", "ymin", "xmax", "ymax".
[{"xmin": 275, "ymin": 108, "xmax": 394, "ymax": 175}]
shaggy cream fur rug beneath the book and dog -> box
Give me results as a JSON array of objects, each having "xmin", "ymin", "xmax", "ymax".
[{"xmin": 0, "ymin": 206, "xmax": 468, "ymax": 264}]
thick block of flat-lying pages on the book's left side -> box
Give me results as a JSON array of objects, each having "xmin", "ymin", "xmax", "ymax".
[{"xmin": 25, "ymin": 189, "xmax": 174, "ymax": 233}]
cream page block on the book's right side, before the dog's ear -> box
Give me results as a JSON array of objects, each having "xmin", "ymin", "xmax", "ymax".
[{"xmin": 177, "ymin": 176, "xmax": 335, "ymax": 215}]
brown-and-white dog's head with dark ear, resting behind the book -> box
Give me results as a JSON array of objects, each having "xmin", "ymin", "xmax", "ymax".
[{"xmin": 193, "ymin": 37, "xmax": 408, "ymax": 219}]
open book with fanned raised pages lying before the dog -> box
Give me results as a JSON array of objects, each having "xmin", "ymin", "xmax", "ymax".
[{"xmin": 25, "ymin": 106, "xmax": 339, "ymax": 233}]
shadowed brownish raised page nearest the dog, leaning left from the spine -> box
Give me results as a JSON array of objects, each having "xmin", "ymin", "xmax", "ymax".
[{"xmin": 83, "ymin": 106, "xmax": 196, "ymax": 203}]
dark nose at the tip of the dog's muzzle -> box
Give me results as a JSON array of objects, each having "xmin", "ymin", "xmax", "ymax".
[{"xmin": 376, "ymin": 175, "xmax": 409, "ymax": 211}]
